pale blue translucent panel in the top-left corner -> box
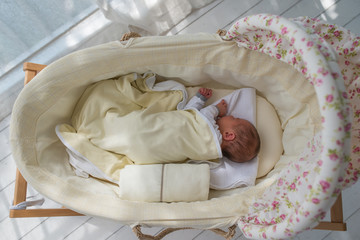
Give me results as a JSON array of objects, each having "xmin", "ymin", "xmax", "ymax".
[{"xmin": 0, "ymin": 0, "xmax": 96, "ymax": 75}]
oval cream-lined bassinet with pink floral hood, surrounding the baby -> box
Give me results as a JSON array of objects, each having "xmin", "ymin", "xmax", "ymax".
[{"xmin": 10, "ymin": 14, "xmax": 360, "ymax": 238}]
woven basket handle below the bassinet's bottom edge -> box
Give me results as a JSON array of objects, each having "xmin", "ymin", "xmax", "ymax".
[{"xmin": 132, "ymin": 225, "xmax": 236, "ymax": 240}]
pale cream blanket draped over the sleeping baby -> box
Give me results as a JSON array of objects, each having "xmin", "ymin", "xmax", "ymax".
[{"xmin": 56, "ymin": 74, "xmax": 221, "ymax": 182}]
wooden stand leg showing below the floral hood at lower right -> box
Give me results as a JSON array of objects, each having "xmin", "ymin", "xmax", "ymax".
[{"xmin": 314, "ymin": 193, "xmax": 346, "ymax": 231}]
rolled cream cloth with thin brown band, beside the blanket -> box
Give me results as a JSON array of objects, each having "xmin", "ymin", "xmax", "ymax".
[{"xmin": 119, "ymin": 164, "xmax": 210, "ymax": 202}]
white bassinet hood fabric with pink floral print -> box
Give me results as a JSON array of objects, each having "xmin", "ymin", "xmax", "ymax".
[{"xmin": 224, "ymin": 14, "xmax": 360, "ymax": 239}]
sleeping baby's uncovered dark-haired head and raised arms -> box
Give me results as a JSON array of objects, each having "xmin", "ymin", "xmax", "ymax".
[{"xmin": 186, "ymin": 88, "xmax": 260, "ymax": 163}]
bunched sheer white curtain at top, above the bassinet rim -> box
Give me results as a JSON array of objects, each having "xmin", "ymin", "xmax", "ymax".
[{"xmin": 97, "ymin": 0, "xmax": 214, "ymax": 35}]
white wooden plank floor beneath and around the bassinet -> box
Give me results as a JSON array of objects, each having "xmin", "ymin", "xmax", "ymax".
[{"xmin": 0, "ymin": 0, "xmax": 360, "ymax": 240}]
